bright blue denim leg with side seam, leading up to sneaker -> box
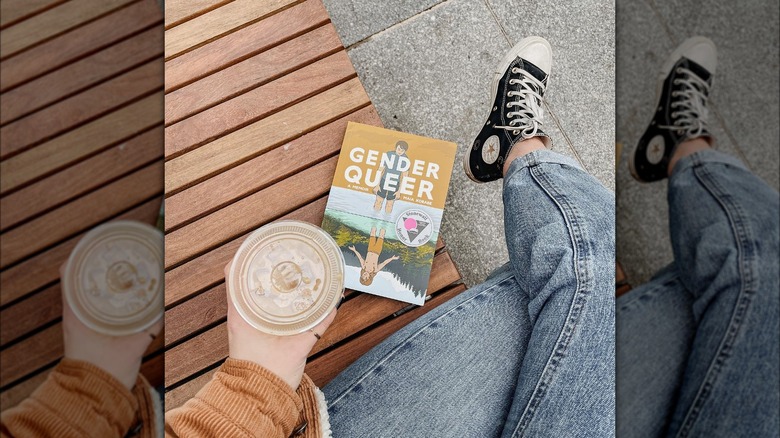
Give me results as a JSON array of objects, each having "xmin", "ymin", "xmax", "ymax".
[{"xmin": 504, "ymin": 146, "xmax": 615, "ymax": 436}]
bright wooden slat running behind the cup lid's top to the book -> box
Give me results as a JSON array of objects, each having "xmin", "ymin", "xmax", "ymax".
[{"xmin": 165, "ymin": 198, "xmax": 327, "ymax": 307}]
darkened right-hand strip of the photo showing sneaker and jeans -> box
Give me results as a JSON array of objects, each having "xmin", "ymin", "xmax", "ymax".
[{"xmin": 616, "ymin": 0, "xmax": 780, "ymax": 437}]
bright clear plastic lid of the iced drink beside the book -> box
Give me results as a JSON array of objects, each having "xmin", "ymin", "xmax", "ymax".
[{"xmin": 228, "ymin": 221, "xmax": 344, "ymax": 335}]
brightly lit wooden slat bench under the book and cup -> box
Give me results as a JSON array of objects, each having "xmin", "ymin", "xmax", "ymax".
[{"xmin": 158, "ymin": 0, "xmax": 465, "ymax": 409}]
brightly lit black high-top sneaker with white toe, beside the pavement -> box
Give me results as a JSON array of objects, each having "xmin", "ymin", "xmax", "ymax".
[{"xmin": 463, "ymin": 37, "xmax": 552, "ymax": 182}]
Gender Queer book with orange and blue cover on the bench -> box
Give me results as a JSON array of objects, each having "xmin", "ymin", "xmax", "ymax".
[{"xmin": 322, "ymin": 122, "xmax": 458, "ymax": 305}]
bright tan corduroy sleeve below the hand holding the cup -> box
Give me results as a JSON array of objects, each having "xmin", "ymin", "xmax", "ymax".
[{"xmin": 165, "ymin": 358, "xmax": 321, "ymax": 438}]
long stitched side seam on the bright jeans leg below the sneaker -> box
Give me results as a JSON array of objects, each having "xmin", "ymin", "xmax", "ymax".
[{"xmin": 512, "ymin": 166, "xmax": 592, "ymax": 437}]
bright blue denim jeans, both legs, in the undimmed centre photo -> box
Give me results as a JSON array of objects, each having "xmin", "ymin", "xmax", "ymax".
[{"xmin": 323, "ymin": 150, "xmax": 615, "ymax": 438}]
